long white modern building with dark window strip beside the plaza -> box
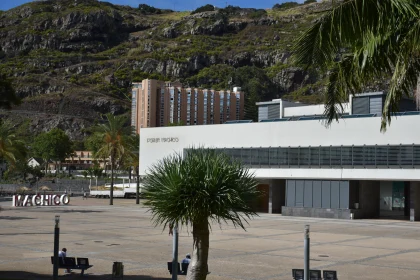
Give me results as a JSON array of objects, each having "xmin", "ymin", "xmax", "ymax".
[{"xmin": 140, "ymin": 92, "xmax": 420, "ymax": 221}]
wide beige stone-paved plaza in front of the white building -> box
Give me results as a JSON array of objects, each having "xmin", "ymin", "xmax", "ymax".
[{"xmin": 0, "ymin": 197, "xmax": 420, "ymax": 280}]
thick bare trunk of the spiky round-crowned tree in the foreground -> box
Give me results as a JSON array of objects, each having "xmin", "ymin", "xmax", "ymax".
[{"xmin": 186, "ymin": 220, "xmax": 210, "ymax": 280}]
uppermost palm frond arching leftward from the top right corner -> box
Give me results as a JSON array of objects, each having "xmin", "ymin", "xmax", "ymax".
[{"xmin": 292, "ymin": 0, "xmax": 418, "ymax": 69}]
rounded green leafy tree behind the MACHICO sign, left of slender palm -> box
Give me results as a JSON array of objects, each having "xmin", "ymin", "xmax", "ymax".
[{"xmin": 32, "ymin": 128, "xmax": 74, "ymax": 172}]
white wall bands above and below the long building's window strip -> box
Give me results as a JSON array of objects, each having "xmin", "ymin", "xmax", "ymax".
[{"xmin": 140, "ymin": 116, "xmax": 420, "ymax": 181}]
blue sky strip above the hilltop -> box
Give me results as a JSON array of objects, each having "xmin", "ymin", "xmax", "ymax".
[{"xmin": 0, "ymin": 0, "xmax": 303, "ymax": 11}]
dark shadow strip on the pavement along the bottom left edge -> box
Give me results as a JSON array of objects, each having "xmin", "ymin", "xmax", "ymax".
[{"xmin": 0, "ymin": 270, "xmax": 175, "ymax": 280}]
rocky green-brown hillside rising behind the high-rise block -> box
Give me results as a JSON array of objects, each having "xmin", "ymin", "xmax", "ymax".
[{"xmin": 0, "ymin": 0, "xmax": 329, "ymax": 140}]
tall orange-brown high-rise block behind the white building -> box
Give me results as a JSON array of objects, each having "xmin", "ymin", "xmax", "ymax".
[{"xmin": 131, "ymin": 79, "xmax": 244, "ymax": 133}]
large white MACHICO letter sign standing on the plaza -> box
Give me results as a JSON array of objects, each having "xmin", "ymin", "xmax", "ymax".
[{"xmin": 13, "ymin": 194, "xmax": 70, "ymax": 207}]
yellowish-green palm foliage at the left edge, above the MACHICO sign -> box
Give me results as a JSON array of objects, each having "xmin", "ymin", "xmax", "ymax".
[{"xmin": 0, "ymin": 120, "xmax": 26, "ymax": 166}]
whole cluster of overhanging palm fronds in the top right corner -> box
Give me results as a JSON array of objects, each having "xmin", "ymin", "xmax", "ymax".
[{"xmin": 293, "ymin": 0, "xmax": 420, "ymax": 129}]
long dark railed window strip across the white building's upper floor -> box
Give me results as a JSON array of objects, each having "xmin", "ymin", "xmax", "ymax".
[{"xmin": 186, "ymin": 144, "xmax": 420, "ymax": 169}]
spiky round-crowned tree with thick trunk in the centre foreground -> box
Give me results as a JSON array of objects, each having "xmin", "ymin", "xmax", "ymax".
[{"xmin": 144, "ymin": 148, "xmax": 259, "ymax": 280}]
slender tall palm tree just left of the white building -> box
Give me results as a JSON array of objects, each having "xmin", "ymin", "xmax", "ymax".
[{"xmin": 94, "ymin": 113, "xmax": 131, "ymax": 205}]
